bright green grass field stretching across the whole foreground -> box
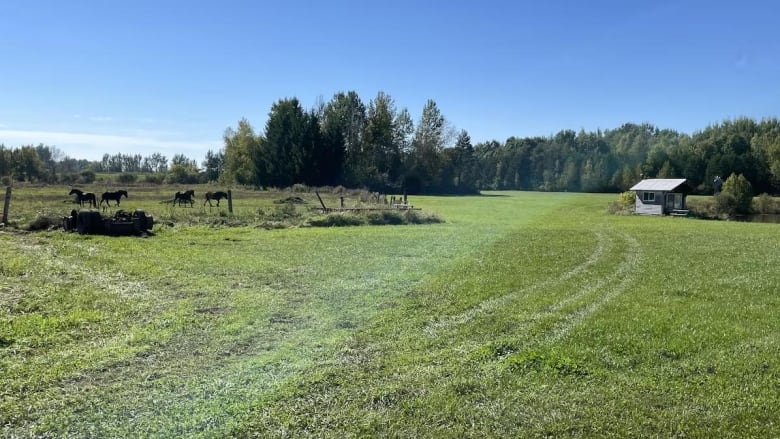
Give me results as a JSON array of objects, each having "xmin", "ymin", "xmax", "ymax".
[{"xmin": 0, "ymin": 188, "xmax": 780, "ymax": 438}]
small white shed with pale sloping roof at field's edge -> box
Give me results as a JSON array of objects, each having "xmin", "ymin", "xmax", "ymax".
[{"xmin": 631, "ymin": 178, "xmax": 690, "ymax": 215}]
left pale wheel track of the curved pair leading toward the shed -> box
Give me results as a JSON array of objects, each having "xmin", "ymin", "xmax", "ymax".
[{"xmin": 425, "ymin": 230, "xmax": 611, "ymax": 337}]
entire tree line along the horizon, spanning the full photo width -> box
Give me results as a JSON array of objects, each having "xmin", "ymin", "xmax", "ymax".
[{"xmin": 0, "ymin": 91, "xmax": 780, "ymax": 194}]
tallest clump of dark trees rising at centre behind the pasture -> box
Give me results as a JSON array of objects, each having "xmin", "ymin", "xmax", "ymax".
[{"xmin": 223, "ymin": 92, "xmax": 466, "ymax": 193}]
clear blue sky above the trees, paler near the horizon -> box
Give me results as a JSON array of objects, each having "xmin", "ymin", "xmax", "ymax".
[{"xmin": 0, "ymin": 0, "xmax": 780, "ymax": 162}]
